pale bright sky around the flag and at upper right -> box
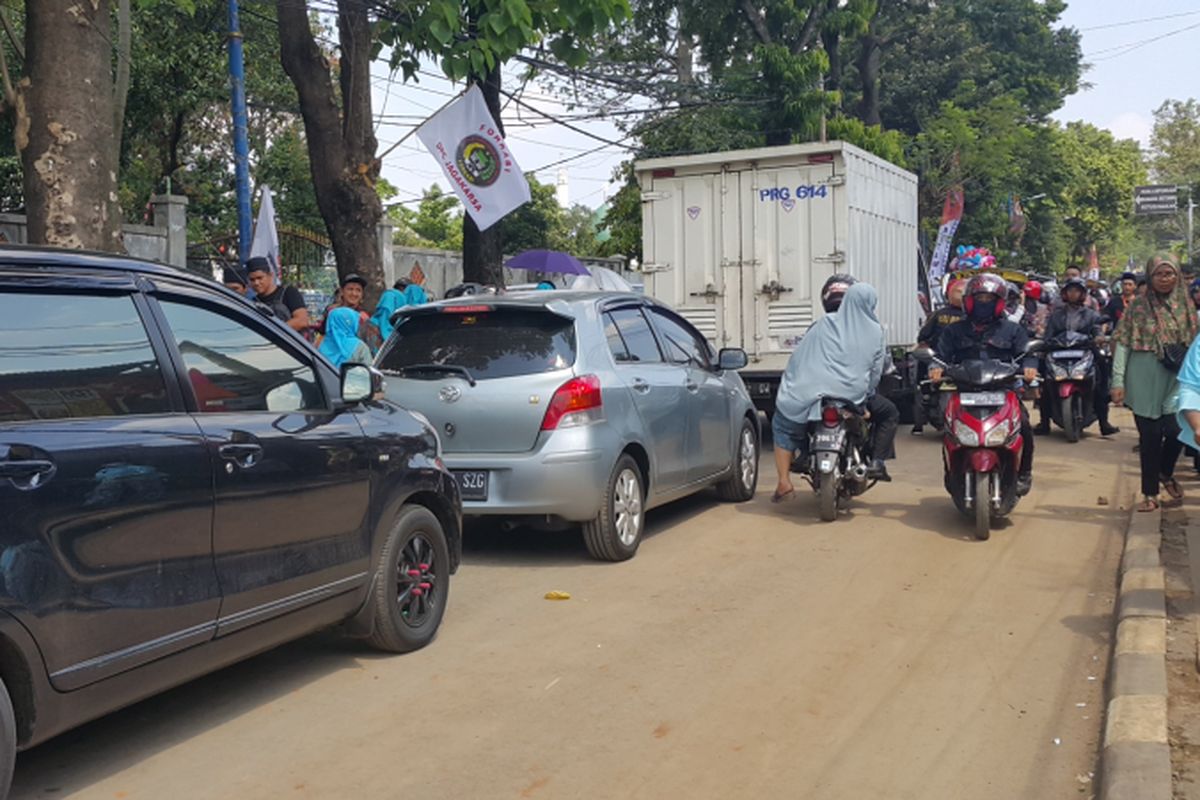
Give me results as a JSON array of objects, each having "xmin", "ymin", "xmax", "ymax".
[{"xmin": 373, "ymin": 0, "xmax": 1200, "ymax": 215}]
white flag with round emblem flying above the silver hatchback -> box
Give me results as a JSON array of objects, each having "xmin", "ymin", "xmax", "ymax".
[{"xmin": 416, "ymin": 85, "xmax": 529, "ymax": 230}]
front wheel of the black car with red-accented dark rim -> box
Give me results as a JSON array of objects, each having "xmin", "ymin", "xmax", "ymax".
[{"xmin": 368, "ymin": 506, "xmax": 450, "ymax": 652}]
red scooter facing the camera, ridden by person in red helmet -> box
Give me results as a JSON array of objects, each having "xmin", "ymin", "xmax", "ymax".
[{"xmin": 916, "ymin": 359, "xmax": 1025, "ymax": 541}]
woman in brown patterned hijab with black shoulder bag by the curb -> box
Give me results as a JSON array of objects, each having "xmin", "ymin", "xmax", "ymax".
[{"xmin": 1112, "ymin": 259, "xmax": 1200, "ymax": 511}]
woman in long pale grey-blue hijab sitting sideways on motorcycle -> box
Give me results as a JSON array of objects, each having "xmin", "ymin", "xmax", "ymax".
[{"xmin": 772, "ymin": 283, "xmax": 887, "ymax": 503}]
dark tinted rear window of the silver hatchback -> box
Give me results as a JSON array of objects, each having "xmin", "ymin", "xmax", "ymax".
[{"xmin": 379, "ymin": 308, "xmax": 575, "ymax": 380}]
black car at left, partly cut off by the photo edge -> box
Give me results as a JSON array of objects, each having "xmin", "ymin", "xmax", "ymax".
[{"xmin": 0, "ymin": 247, "xmax": 462, "ymax": 798}]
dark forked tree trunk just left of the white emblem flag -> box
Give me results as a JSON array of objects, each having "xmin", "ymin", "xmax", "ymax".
[{"xmin": 276, "ymin": 0, "xmax": 385, "ymax": 307}]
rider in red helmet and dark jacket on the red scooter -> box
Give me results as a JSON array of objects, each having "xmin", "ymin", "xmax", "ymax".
[{"xmin": 929, "ymin": 272, "xmax": 1038, "ymax": 495}]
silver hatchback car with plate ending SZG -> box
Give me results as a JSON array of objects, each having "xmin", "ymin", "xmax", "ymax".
[{"xmin": 376, "ymin": 291, "xmax": 760, "ymax": 561}]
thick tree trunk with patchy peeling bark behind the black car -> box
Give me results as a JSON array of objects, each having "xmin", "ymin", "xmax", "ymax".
[{"xmin": 16, "ymin": 0, "xmax": 124, "ymax": 252}]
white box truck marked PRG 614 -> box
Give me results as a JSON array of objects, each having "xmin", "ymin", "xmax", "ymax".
[{"xmin": 635, "ymin": 142, "xmax": 922, "ymax": 413}]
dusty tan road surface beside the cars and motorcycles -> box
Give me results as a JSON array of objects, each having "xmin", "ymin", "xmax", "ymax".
[{"xmin": 13, "ymin": 420, "xmax": 1133, "ymax": 800}]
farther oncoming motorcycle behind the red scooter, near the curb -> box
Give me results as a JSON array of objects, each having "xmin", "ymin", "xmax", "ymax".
[{"xmin": 1042, "ymin": 331, "xmax": 1104, "ymax": 443}]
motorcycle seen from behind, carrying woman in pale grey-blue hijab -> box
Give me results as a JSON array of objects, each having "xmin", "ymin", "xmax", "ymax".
[{"xmin": 792, "ymin": 397, "xmax": 878, "ymax": 522}]
